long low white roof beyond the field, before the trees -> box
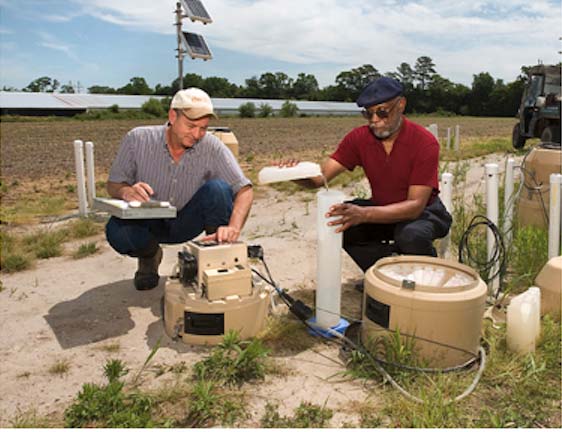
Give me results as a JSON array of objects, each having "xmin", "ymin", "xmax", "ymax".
[{"xmin": 0, "ymin": 92, "xmax": 359, "ymax": 115}]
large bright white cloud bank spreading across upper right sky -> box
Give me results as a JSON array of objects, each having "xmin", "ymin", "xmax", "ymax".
[{"xmin": 65, "ymin": 0, "xmax": 560, "ymax": 80}]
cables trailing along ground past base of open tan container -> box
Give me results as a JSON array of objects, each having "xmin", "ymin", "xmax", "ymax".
[{"xmin": 252, "ymin": 253, "xmax": 486, "ymax": 404}]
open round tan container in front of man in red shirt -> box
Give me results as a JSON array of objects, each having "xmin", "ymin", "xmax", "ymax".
[{"xmin": 362, "ymin": 255, "xmax": 487, "ymax": 367}]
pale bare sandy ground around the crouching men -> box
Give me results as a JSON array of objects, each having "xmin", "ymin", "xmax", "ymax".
[{"xmin": 0, "ymin": 156, "xmax": 516, "ymax": 427}]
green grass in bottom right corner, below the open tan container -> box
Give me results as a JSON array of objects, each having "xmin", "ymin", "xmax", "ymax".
[{"xmin": 344, "ymin": 315, "xmax": 562, "ymax": 428}]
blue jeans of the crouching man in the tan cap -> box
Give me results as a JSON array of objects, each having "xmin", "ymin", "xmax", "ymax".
[{"xmin": 105, "ymin": 179, "xmax": 234, "ymax": 257}]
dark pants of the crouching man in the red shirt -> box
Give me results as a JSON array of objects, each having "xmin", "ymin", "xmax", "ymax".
[{"xmin": 343, "ymin": 197, "xmax": 452, "ymax": 272}]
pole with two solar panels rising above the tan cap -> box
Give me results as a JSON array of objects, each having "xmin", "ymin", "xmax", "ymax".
[{"xmin": 174, "ymin": 0, "xmax": 213, "ymax": 90}]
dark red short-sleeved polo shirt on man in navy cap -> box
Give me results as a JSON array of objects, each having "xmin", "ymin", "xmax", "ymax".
[{"xmin": 331, "ymin": 117, "xmax": 439, "ymax": 205}]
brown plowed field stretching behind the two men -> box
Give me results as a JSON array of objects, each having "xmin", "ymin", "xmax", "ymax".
[{"xmin": 0, "ymin": 117, "xmax": 514, "ymax": 182}]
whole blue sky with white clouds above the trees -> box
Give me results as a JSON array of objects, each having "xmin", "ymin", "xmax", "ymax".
[{"xmin": 0, "ymin": 0, "xmax": 562, "ymax": 92}]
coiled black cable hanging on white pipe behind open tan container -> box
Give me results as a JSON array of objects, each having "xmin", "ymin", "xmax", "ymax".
[{"xmin": 458, "ymin": 215, "xmax": 506, "ymax": 300}]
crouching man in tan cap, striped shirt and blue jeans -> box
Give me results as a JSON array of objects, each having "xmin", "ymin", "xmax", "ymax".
[{"xmin": 106, "ymin": 88, "xmax": 253, "ymax": 290}]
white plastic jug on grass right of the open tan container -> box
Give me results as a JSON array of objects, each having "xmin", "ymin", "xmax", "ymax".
[{"xmin": 507, "ymin": 287, "xmax": 541, "ymax": 354}]
